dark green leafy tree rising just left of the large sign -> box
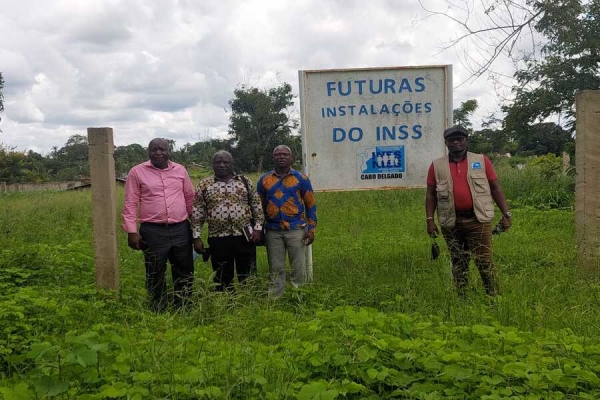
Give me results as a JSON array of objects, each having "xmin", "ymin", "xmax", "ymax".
[{"xmin": 229, "ymin": 83, "xmax": 298, "ymax": 171}]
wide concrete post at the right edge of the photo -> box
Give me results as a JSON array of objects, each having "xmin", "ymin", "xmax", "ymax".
[{"xmin": 575, "ymin": 90, "xmax": 600, "ymax": 278}]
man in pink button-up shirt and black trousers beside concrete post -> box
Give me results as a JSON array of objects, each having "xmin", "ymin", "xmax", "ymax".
[{"xmin": 122, "ymin": 138, "xmax": 194, "ymax": 312}]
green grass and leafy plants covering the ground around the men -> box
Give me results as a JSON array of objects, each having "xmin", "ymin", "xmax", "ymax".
[{"xmin": 0, "ymin": 165, "xmax": 600, "ymax": 400}]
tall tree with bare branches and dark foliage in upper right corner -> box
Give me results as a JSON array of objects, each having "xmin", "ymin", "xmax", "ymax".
[{"xmin": 422, "ymin": 0, "xmax": 600, "ymax": 131}]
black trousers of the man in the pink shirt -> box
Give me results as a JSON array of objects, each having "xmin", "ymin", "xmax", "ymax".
[{"xmin": 140, "ymin": 220, "xmax": 194, "ymax": 311}]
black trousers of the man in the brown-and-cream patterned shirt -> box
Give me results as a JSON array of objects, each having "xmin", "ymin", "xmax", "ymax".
[{"xmin": 208, "ymin": 236, "xmax": 256, "ymax": 291}]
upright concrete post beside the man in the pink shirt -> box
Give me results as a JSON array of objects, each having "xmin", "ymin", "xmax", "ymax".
[{"xmin": 88, "ymin": 128, "xmax": 119, "ymax": 290}]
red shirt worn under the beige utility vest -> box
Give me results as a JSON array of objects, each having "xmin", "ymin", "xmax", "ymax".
[{"xmin": 427, "ymin": 156, "xmax": 498, "ymax": 211}]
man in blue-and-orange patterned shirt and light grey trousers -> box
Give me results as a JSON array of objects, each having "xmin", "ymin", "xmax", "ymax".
[{"xmin": 256, "ymin": 145, "xmax": 317, "ymax": 297}]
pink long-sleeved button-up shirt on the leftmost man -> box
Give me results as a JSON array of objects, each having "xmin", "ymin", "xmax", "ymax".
[{"xmin": 122, "ymin": 161, "xmax": 195, "ymax": 233}]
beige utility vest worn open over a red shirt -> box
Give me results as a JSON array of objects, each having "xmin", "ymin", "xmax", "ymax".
[{"xmin": 433, "ymin": 152, "xmax": 494, "ymax": 228}]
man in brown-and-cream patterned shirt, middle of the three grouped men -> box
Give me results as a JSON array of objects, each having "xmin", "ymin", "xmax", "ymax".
[{"xmin": 192, "ymin": 150, "xmax": 264, "ymax": 291}]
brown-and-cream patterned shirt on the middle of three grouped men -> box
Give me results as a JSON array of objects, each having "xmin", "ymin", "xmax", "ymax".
[{"xmin": 192, "ymin": 175, "xmax": 264, "ymax": 239}]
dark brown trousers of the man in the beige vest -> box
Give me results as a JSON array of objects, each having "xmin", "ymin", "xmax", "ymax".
[{"xmin": 442, "ymin": 217, "xmax": 500, "ymax": 296}]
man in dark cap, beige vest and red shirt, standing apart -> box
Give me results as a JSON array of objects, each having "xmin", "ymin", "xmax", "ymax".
[{"xmin": 425, "ymin": 126, "xmax": 512, "ymax": 296}]
